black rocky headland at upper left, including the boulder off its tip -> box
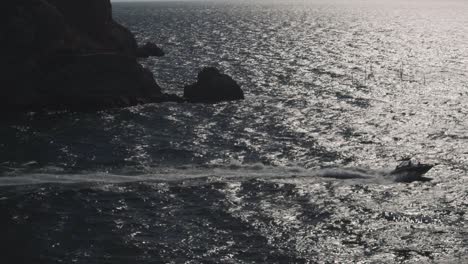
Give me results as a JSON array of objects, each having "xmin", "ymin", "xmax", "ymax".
[{"xmin": 0, "ymin": 0, "xmax": 243, "ymax": 111}]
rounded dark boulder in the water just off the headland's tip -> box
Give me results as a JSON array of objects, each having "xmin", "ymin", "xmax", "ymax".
[{"xmin": 184, "ymin": 67, "xmax": 244, "ymax": 103}]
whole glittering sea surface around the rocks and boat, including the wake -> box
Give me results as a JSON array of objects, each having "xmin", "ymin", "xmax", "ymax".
[{"xmin": 0, "ymin": 0, "xmax": 468, "ymax": 263}]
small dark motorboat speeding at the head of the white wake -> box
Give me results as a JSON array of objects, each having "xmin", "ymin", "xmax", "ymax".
[{"xmin": 390, "ymin": 159, "xmax": 434, "ymax": 182}]
